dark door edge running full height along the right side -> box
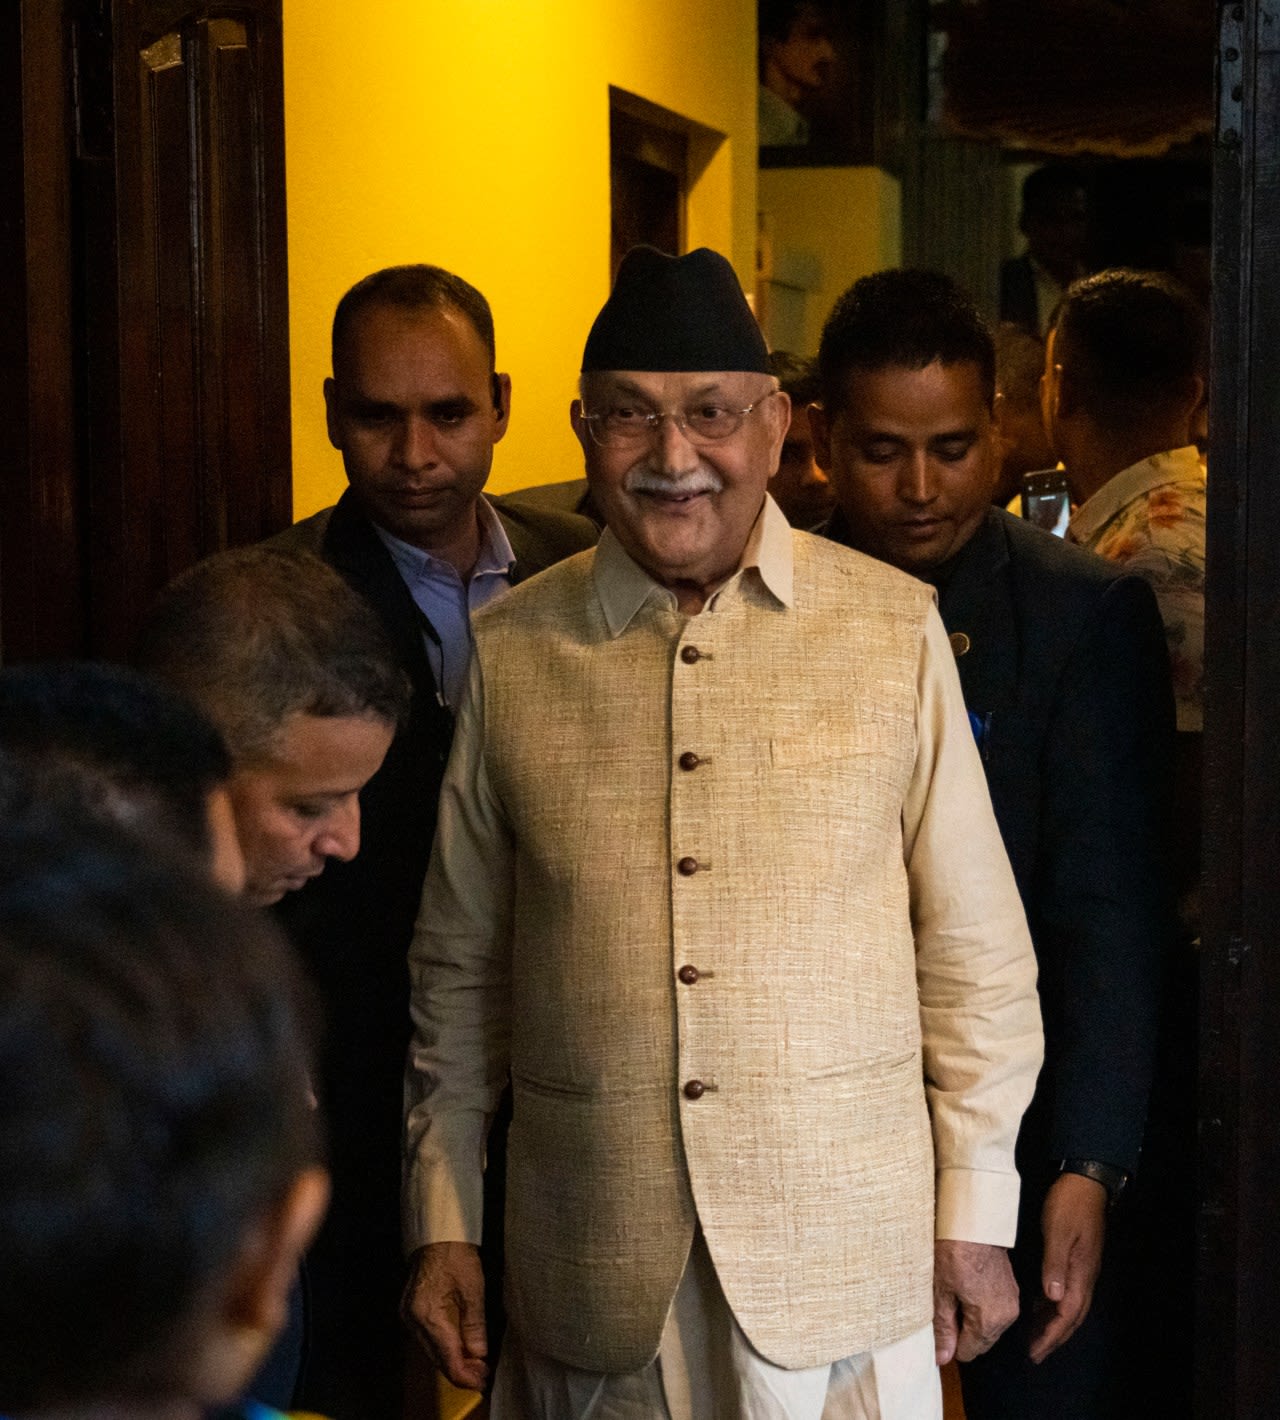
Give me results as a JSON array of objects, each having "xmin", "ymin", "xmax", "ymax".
[{"xmin": 1196, "ymin": 0, "xmax": 1280, "ymax": 1420}]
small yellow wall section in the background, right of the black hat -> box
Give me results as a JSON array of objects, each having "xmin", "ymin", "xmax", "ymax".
[{"xmin": 759, "ymin": 168, "xmax": 902, "ymax": 355}]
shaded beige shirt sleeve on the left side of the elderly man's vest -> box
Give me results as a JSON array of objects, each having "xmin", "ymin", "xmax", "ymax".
[{"xmin": 402, "ymin": 656, "xmax": 514, "ymax": 1252}]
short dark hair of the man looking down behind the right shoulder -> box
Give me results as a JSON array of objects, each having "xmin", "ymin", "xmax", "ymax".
[{"xmin": 818, "ymin": 271, "xmax": 996, "ymax": 413}]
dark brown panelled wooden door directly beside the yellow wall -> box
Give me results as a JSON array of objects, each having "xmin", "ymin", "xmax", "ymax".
[{"xmin": 90, "ymin": 4, "xmax": 290, "ymax": 650}]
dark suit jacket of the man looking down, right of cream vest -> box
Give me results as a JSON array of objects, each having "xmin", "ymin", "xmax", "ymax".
[{"xmin": 828, "ymin": 508, "xmax": 1173, "ymax": 1196}]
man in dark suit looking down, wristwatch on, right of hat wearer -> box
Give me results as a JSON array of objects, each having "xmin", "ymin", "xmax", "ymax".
[{"xmin": 811, "ymin": 271, "xmax": 1173, "ymax": 1420}]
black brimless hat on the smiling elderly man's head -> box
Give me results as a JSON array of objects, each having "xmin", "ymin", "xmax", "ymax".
[{"xmin": 582, "ymin": 247, "xmax": 770, "ymax": 375}]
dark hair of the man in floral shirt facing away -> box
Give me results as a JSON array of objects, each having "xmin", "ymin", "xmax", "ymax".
[{"xmin": 1054, "ymin": 267, "xmax": 1208, "ymax": 430}]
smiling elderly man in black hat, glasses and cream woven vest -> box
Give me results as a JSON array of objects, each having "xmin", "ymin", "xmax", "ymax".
[{"xmin": 405, "ymin": 249, "xmax": 1041, "ymax": 1420}]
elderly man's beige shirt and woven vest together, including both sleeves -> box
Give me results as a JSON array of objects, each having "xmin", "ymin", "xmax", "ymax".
[{"xmin": 405, "ymin": 500, "xmax": 1041, "ymax": 1370}]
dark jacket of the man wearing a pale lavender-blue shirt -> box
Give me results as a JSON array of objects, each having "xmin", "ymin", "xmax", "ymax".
[{"xmin": 271, "ymin": 490, "xmax": 598, "ymax": 1420}]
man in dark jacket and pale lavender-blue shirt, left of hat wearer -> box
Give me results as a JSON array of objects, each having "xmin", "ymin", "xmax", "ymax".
[{"xmin": 277, "ymin": 266, "xmax": 597, "ymax": 1420}]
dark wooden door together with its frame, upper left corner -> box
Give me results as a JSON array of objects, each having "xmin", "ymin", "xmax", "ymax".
[{"xmin": 0, "ymin": 0, "xmax": 293, "ymax": 662}]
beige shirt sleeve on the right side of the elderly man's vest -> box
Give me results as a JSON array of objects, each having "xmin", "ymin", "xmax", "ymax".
[{"xmin": 902, "ymin": 608, "xmax": 1044, "ymax": 1247}]
